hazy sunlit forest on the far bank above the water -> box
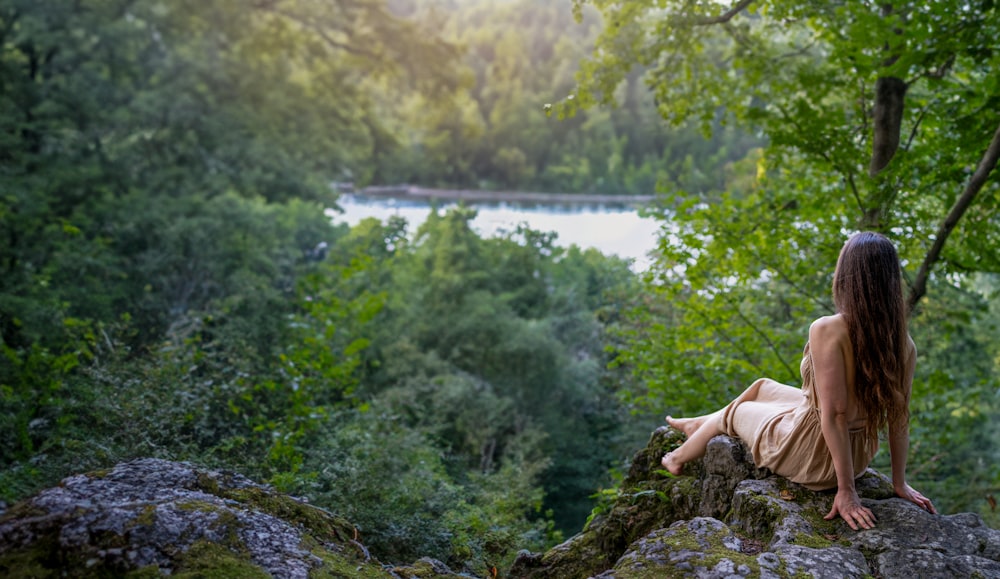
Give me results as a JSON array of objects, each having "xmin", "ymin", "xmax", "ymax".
[{"xmin": 375, "ymin": 0, "xmax": 759, "ymax": 195}]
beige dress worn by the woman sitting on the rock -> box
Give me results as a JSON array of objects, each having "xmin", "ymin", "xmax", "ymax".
[{"xmin": 722, "ymin": 343, "xmax": 878, "ymax": 490}]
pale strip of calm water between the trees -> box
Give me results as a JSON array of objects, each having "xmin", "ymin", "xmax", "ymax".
[{"xmin": 331, "ymin": 195, "xmax": 660, "ymax": 271}]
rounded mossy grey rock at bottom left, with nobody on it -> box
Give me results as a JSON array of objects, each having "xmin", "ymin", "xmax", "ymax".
[{"xmin": 0, "ymin": 459, "xmax": 457, "ymax": 579}]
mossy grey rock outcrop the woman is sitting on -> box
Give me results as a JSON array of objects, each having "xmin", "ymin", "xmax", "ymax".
[{"xmin": 510, "ymin": 427, "xmax": 1000, "ymax": 579}]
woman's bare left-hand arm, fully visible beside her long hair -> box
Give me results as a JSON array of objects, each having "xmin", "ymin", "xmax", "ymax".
[{"xmin": 809, "ymin": 317, "xmax": 875, "ymax": 530}]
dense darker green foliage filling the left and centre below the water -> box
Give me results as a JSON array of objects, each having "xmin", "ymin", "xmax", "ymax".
[{"xmin": 0, "ymin": 0, "xmax": 652, "ymax": 571}]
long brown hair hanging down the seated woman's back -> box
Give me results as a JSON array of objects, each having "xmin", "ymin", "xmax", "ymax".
[{"xmin": 833, "ymin": 231, "xmax": 909, "ymax": 437}]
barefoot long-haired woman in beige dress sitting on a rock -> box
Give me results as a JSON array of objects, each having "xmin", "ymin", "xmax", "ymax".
[{"xmin": 662, "ymin": 232, "xmax": 937, "ymax": 530}]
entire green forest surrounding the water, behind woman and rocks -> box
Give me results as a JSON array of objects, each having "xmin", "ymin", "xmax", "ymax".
[{"xmin": 0, "ymin": 0, "xmax": 1000, "ymax": 575}]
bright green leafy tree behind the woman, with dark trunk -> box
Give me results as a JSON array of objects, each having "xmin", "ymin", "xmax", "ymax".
[{"xmin": 555, "ymin": 0, "xmax": 1000, "ymax": 516}]
